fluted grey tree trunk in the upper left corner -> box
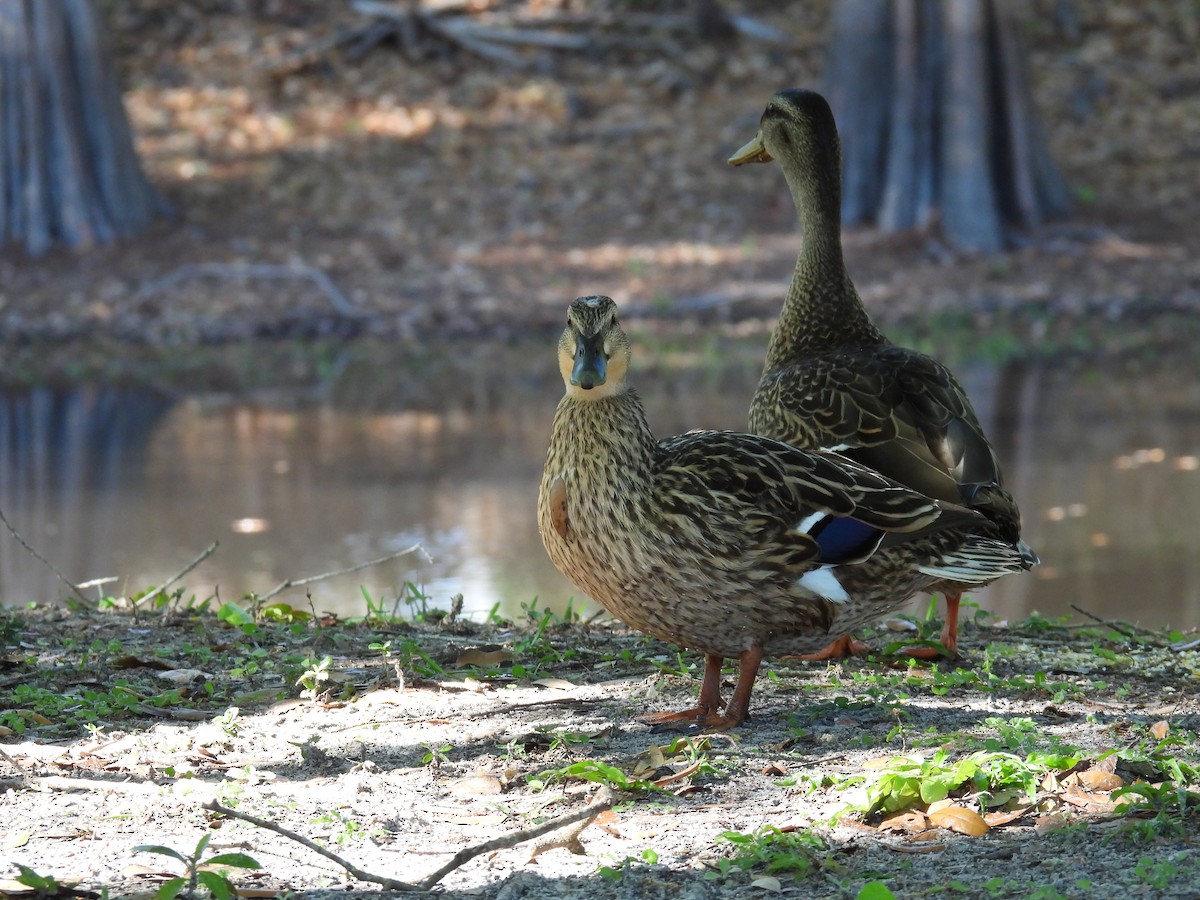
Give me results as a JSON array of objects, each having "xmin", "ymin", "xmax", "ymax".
[{"xmin": 0, "ymin": 0, "xmax": 167, "ymax": 256}]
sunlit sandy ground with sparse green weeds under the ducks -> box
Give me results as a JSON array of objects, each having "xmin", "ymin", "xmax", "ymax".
[{"xmin": 0, "ymin": 612, "xmax": 1200, "ymax": 898}]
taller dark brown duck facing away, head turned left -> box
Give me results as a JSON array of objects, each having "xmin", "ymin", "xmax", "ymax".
[{"xmin": 730, "ymin": 90, "xmax": 1037, "ymax": 656}]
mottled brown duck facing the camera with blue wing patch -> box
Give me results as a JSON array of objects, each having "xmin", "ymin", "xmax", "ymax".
[{"xmin": 538, "ymin": 296, "xmax": 1025, "ymax": 728}]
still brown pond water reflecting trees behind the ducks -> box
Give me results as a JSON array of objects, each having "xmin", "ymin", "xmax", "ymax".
[{"xmin": 0, "ymin": 336, "xmax": 1200, "ymax": 628}]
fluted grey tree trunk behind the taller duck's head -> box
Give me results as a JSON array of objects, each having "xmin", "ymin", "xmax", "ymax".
[{"xmin": 824, "ymin": 0, "xmax": 1069, "ymax": 252}]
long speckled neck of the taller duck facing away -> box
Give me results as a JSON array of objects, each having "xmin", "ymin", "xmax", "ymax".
[{"xmin": 767, "ymin": 157, "xmax": 887, "ymax": 370}]
